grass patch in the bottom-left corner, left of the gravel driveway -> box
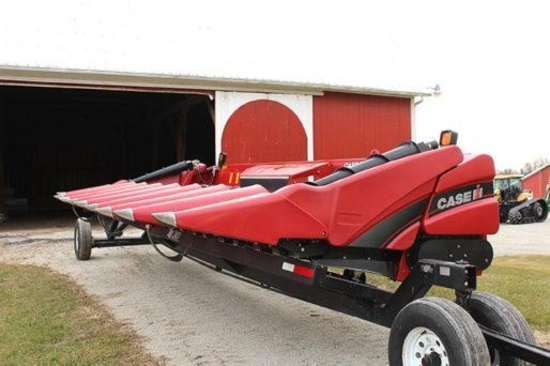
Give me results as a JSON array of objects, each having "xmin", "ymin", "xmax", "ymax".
[{"xmin": 0, "ymin": 264, "xmax": 164, "ymax": 365}]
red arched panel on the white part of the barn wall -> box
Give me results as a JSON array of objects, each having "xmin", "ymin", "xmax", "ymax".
[{"xmin": 222, "ymin": 100, "xmax": 307, "ymax": 163}]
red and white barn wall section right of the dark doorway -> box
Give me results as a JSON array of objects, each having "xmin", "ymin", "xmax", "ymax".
[{"xmin": 215, "ymin": 86, "xmax": 415, "ymax": 163}]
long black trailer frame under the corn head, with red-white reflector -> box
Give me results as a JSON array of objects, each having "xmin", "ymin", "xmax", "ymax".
[{"xmin": 75, "ymin": 218, "xmax": 550, "ymax": 366}]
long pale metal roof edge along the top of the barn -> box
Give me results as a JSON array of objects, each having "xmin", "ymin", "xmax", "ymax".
[{"xmin": 0, "ymin": 65, "xmax": 433, "ymax": 98}]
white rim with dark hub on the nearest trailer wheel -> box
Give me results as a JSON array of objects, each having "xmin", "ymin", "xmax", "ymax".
[{"xmin": 403, "ymin": 327, "xmax": 449, "ymax": 366}]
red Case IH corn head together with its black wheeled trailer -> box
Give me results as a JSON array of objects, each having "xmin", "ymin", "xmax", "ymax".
[{"xmin": 55, "ymin": 131, "xmax": 550, "ymax": 365}]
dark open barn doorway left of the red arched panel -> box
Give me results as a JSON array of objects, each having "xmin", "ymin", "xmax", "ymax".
[{"xmin": 0, "ymin": 86, "xmax": 215, "ymax": 216}]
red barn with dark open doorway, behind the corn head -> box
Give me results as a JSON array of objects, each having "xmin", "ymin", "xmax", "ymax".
[{"xmin": 0, "ymin": 65, "xmax": 430, "ymax": 212}]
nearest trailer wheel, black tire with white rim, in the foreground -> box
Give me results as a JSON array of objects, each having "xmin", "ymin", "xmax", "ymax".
[{"xmin": 388, "ymin": 297, "xmax": 490, "ymax": 366}]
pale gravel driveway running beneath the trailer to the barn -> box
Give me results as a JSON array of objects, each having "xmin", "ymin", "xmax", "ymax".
[{"xmin": 0, "ymin": 213, "xmax": 550, "ymax": 366}]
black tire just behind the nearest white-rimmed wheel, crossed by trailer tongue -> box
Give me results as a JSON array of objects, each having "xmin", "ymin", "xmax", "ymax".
[{"xmin": 468, "ymin": 291, "xmax": 536, "ymax": 366}]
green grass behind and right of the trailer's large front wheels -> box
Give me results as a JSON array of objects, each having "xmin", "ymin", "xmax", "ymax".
[{"xmin": 367, "ymin": 256, "xmax": 550, "ymax": 333}]
